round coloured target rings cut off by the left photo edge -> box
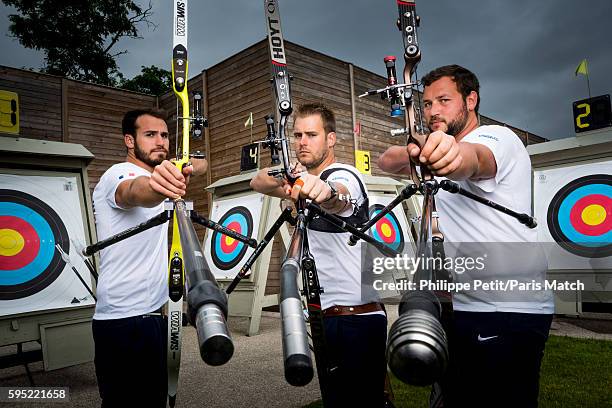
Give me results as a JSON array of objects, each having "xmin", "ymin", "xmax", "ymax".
[{"xmin": 0, "ymin": 189, "xmax": 70, "ymax": 300}]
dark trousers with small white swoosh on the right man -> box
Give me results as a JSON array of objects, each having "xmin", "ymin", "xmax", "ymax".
[{"xmin": 441, "ymin": 312, "xmax": 552, "ymax": 408}]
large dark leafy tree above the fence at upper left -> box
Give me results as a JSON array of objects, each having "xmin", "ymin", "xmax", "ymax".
[{"xmin": 2, "ymin": 0, "xmax": 155, "ymax": 85}]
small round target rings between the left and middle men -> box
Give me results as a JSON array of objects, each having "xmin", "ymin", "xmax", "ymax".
[{"xmin": 211, "ymin": 206, "xmax": 253, "ymax": 270}]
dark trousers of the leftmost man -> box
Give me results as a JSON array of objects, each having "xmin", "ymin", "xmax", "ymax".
[{"xmin": 92, "ymin": 315, "xmax": 168, "ymax": 408}]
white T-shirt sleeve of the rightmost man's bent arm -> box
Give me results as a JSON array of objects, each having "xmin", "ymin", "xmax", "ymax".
[{"xmin": 461, "ymin": 126, "xmax": 524, "ymax": 193}]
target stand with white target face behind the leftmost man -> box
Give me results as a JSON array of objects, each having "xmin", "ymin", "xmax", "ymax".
[{"xmin": 0, "ymin": 136, "xmax": 95, "ymax": 370}]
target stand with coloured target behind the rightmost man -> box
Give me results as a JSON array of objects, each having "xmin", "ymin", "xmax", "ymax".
[{"xmin": 527, "ymin": 128, "xmax": 612, "ymax": 315}]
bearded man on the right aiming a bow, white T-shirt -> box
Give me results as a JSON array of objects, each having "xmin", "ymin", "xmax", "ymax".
[{"xmin": 378, "ymin": 65, "xmax": 554, "ymax": 408}]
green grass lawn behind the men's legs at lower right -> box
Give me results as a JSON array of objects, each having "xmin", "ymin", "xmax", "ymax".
[{"xmin": 305, "ymin": 336, "xmax": 612, "ymax": 408}]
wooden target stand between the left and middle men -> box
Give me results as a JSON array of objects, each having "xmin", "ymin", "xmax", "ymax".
[{"xmin": 204, "ymin": 171, "xmax": 290, "ymax": 336}]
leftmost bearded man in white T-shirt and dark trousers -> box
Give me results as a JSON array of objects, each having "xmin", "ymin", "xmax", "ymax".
[{"xmin": 92, "ymin": 109, "xmax": 207, "ymax": 407}]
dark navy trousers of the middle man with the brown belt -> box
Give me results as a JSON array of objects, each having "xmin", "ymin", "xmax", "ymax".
[{"xmin": 321, "ymin": 314, "xmax": 387, "ymax": 408}]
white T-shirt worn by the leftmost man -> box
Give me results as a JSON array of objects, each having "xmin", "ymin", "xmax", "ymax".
[{"xmin": 93, "ymin": 162, "xmax": 168, "ymax": 320}]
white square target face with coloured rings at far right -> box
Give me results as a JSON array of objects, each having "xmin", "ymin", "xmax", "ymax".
[{"xmin": 534, "ymin": 162, "xmax": 612, "ymax": 269}]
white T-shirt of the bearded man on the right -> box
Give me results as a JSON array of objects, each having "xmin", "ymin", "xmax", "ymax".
[{"xmin": 436, "ymin": 125, "xmax": 554, "ymax": 314}]
